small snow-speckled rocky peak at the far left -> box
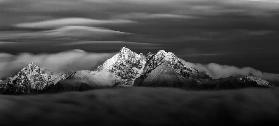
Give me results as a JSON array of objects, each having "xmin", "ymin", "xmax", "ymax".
[{"xmin": 4, "ymin": 63, "xmax": 67, "ymax": 94}]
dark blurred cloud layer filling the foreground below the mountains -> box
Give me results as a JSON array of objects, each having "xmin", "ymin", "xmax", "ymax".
[{"xmin": 0, "ymin": 87, "xmax": 279, "ymax": 126}]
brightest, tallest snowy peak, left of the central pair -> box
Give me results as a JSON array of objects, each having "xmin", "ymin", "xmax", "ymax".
[{"xmin": 98, "ymin": 47, "xmax": 146, "ymax": 86}]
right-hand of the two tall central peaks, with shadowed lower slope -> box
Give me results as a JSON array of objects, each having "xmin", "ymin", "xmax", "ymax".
[{"xmin": 136, "ymin": 50, "xmax": 211, "ymax": 87}]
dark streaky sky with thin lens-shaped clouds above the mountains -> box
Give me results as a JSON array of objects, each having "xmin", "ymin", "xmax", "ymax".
[{"xmin": 0, "ymin": 0, "xmax": 279, "ymax": 73}]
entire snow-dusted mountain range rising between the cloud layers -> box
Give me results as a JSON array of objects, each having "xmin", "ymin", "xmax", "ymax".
[{"xmin": 0, "ymin": 47, "xmax": 272, "ymax": 94}]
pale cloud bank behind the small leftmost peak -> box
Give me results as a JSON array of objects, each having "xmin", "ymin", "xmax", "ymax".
[{"xmin": 0, "ymin": 50, "xmax": 113, "ymax": 78}]
